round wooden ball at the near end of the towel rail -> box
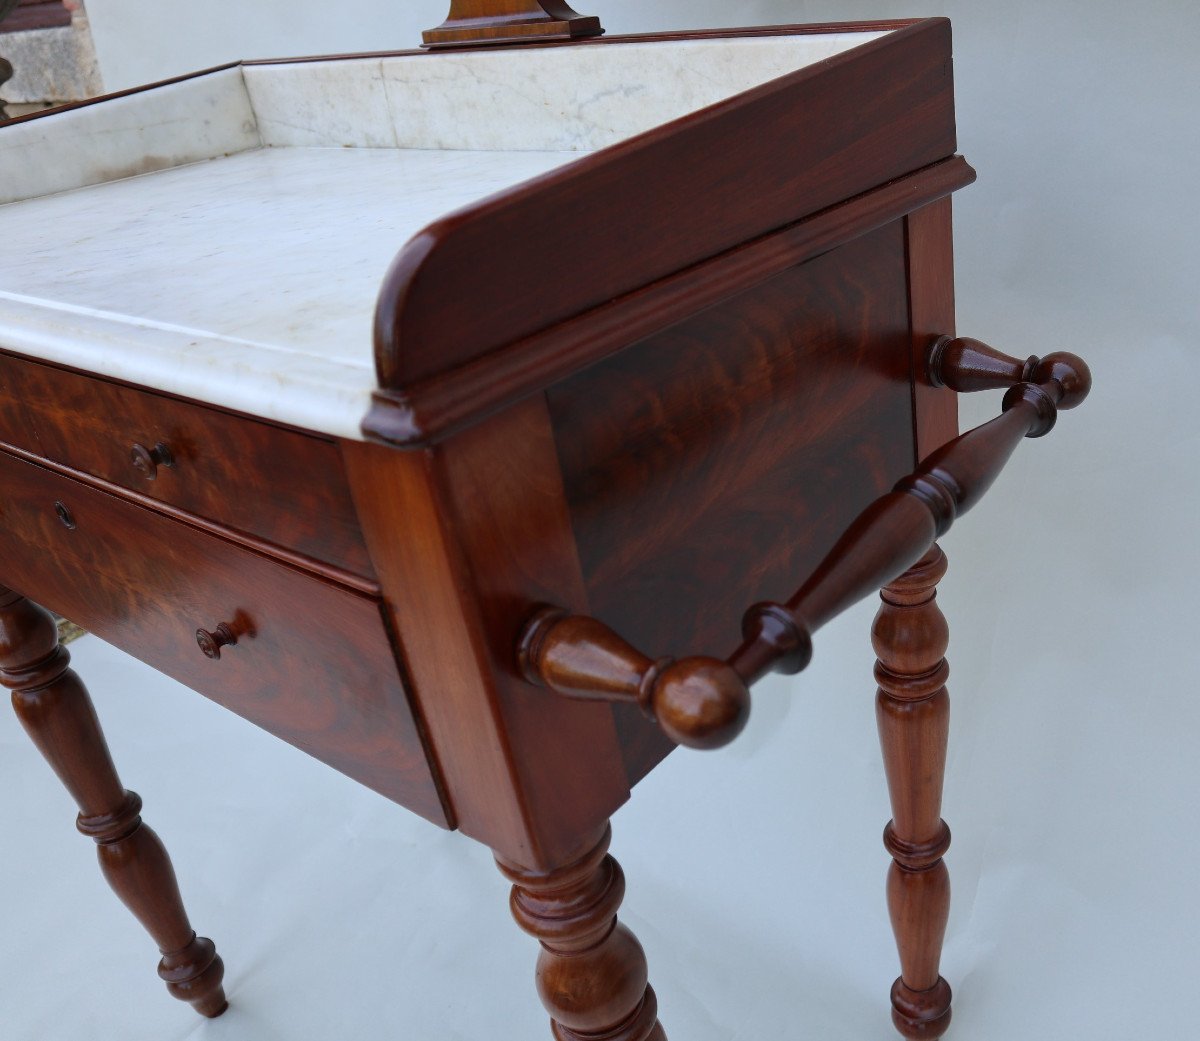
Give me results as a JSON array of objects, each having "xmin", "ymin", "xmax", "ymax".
[{"xmin": 648, "ymin": 657, "xmax": 750, "ymax": 748}]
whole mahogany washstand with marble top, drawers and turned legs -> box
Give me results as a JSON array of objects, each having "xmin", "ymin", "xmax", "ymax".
[{"xmin": 0, "ymin": 0, "xmax": 1090, "ymax": 1041}]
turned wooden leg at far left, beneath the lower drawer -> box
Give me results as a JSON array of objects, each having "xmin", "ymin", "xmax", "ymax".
[{"xmin": 0, "ymin": 586, "xmax": 226, "ymax": 1017}]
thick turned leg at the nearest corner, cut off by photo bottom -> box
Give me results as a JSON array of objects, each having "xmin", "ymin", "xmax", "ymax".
[{"xmin": 497, "ymin": 826, "xmax": 666, "ymax": 1041}]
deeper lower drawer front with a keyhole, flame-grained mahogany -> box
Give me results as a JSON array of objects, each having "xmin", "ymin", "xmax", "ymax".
[{"xmin": 0, "ymin": 452, "xmax": 448, "ymax": 825}]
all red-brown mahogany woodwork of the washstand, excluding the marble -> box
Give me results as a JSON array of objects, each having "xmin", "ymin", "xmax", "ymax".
[{"xmin": 0, "ymin": 20, "xmax": 1090, "ymax": 1041}]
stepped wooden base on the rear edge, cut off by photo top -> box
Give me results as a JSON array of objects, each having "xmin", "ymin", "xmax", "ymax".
[{"xmin": 421, "ymin": 0, "xmax": 604, "ymax": 48}]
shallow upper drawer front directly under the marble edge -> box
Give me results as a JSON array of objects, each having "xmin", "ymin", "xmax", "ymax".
[{"xmin": 0, "ymin": 354, "xmax": 373, "ymax": 578}]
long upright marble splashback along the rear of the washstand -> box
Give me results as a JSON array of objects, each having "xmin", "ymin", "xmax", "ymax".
[{"xmin": 244, "ymin": 32, "xmax": 886, "ymax": 151}]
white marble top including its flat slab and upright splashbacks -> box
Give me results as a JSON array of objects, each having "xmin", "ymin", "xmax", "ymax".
[{"xmin": 0, "ymin": 32, "xmax": 881, "ymax": 438}]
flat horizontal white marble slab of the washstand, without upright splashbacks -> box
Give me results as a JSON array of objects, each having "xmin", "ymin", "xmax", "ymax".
[{"xmin": 0, "ymin": 149, "xmax": 576, "ymax": 438}]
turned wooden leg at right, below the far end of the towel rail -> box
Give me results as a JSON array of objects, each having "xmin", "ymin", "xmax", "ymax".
[{"xmin": 871, "ymin": 546, "xmax": 950, "ymax": 1039}]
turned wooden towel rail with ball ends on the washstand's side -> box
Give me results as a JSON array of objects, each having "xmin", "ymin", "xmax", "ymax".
[{"xmin": 517, "ymin": 337, "xmax": 1092, "ymax": 748}]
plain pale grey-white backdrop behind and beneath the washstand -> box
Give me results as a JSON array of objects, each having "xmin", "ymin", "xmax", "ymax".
[{"xmin": 0, "ymin": 0, "xmax": 1200, "ymax": 1041}]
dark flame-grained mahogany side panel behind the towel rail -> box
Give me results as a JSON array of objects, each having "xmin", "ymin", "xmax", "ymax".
[{"xmin": 548, "ymin": 222, "xmax": 913, "ymax": 783}]
